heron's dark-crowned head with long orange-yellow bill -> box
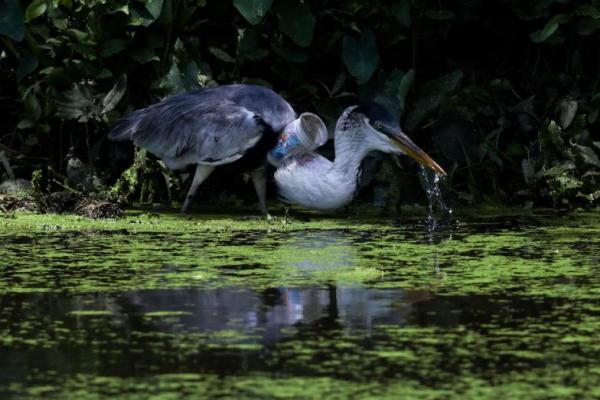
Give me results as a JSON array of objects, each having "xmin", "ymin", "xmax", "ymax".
[{"xmin": 340, "ymin": 102, "xmax": 446, "ymax": 175}]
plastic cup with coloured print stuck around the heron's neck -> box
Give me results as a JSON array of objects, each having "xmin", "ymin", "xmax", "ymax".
[{"xmin": 267, "ymin": 113, "xmax": 328, "ymax": 167}]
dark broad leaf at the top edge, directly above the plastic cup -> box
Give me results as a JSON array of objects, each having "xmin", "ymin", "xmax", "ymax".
[{"xmin": 279, "ymin": 0, "xmax": 317, "ymax": 47}]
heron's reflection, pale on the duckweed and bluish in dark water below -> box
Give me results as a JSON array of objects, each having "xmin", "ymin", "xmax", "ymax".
[{"xmin": 113, "ymin": 231, "xmax": 430, "ymax": 342}]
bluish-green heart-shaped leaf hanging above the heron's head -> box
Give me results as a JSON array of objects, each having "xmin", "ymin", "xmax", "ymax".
[{"xmin": 342, "ymin": 29, "xmax": 379, "ymax": 84}]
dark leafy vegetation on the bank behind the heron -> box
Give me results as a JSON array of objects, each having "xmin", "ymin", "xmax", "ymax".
[{"xmin": 0, "ymin": 0, "xmax": 600, "ymax": 208}]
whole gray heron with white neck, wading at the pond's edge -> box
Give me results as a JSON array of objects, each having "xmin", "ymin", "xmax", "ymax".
[{"xmin": 109, "ymin": 84, "xmax": 445, "ymax": 214}]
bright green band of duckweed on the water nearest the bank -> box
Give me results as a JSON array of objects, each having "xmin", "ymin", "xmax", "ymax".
[{"xmin": 0, "ymin": 213, "xmax": 600, "ymax": 298}]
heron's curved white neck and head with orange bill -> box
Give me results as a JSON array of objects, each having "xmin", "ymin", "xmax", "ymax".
[{"xmin": 275, "ymin": 103, "xmax": 446, "ymax": 210}]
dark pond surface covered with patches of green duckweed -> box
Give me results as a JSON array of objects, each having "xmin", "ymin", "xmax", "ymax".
[{"xmin": 0, "ymin": 214, "xmax": 600, "ymax": 399}]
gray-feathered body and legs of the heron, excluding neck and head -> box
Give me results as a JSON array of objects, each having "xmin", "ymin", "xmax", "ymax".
[{"xmin": 109, "ymin": 84, "xmax": 296, "ymax": 213}]
